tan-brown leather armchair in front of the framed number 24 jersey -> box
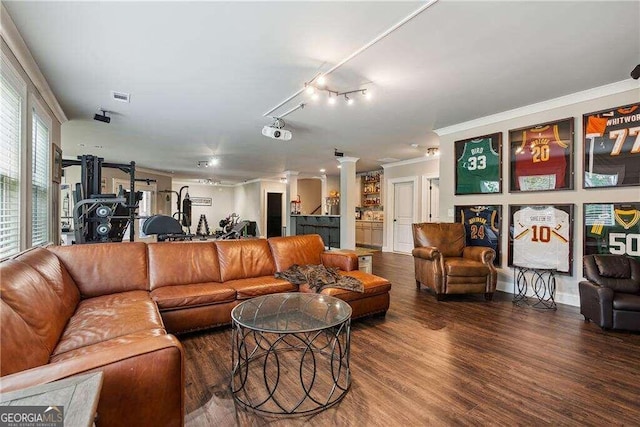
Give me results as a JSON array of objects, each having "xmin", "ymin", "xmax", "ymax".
[{"xmin": 412, "ymin": 222, "xmax": 497, "ymax": 301}]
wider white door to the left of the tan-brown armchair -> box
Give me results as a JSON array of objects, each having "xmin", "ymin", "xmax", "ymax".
[{"xmin": 393, "ymin": 181, "xmax": 415, "ymax": 253}]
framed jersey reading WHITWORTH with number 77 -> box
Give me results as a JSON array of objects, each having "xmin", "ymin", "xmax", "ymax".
[{"xmin": 582, "ymin": 103, "xmax": 640, "ymax": 188}]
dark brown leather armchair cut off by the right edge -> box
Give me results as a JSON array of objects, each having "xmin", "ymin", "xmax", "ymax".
[{"xmin": 578, "ymin": 255, "xmax": 640, "ymax": 331}]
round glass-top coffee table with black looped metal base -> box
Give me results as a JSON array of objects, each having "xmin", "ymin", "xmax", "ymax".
[{"xmin": 231, "ymin": 293, "xmax": 351, "ymax": 416}]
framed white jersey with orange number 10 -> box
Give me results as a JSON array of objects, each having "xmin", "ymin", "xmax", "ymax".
[{"xmin": 509, "ymin": 204, "xmax": 573, "ymax": 276}]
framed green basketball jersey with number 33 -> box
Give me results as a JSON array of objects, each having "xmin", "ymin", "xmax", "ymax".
[{"xmin": 455, "ymin": 133, "xmax": 502, "ymax": 194}]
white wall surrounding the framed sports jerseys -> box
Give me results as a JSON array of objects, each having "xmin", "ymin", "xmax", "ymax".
[{"xmin": 440, "ymin": 85, "xmax": 640, "ymax": 306}]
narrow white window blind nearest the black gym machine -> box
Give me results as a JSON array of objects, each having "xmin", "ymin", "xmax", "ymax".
[{"xmin": 31, "ymin": 110, "xmax": 50, "ymax": 246}]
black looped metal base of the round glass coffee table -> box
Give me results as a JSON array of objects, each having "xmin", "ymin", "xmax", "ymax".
[{"xmin": 231, "ymin": 319, "xmax": 351, "ymax": 416}]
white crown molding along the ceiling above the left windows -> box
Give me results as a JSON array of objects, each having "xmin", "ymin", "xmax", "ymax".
[{"xmin": 0, "ymin": 4, "xmax": 68, "ymax": 124}]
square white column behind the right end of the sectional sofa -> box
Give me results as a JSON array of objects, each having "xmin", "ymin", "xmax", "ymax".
[{"xmin": 338, "ymin": 157, "xmax": 360, "ymax": 249}]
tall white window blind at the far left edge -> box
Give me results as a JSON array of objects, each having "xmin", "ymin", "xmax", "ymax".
[{"xmin": 0, "ymin": 72, "xmax": 23, "ymax": 259}]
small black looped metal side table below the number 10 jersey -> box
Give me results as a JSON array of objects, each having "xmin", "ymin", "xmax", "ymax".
[{"xmin": 513, "ymin": 267, "xmax": 558, "ymax": 310}]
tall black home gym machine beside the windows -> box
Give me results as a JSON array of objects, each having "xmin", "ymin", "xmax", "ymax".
[{"xmin": 62, "ymin": 154, "xmax": 142, "ymax": 244}]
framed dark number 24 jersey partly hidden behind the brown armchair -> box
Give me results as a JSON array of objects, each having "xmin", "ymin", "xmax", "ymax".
[{"xmin": 455, "ymin": 205, "xmax": 502, "ymax": 267}]
